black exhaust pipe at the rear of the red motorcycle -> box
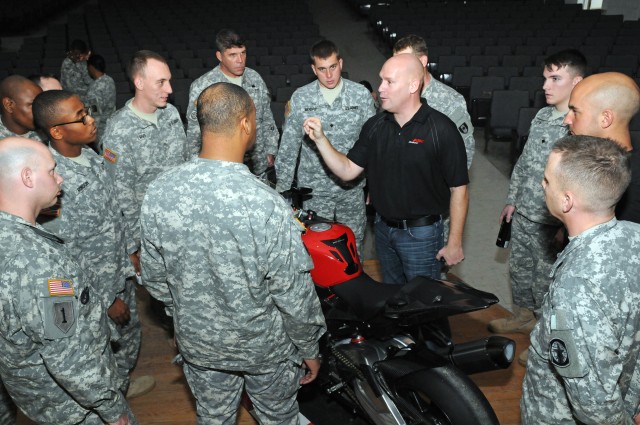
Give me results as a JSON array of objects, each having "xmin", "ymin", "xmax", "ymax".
[{"xmin": 449, "ymin": 336, "xmax": 516, "ymax": 375}]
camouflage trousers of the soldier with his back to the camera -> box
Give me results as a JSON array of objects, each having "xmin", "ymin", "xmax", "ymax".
[{"xmin": 183, "ymin": 361, "xmax": 304, "ymax": 425}]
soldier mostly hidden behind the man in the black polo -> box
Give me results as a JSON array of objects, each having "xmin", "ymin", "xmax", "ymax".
[{"xmin": 393, "ymin": 34, "xmax": 476, "ymax": 168}]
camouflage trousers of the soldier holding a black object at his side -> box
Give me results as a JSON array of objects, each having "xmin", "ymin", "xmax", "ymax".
[{"xmin": 509, "ymin": 213, "xmax": 562, "ymax": 317}]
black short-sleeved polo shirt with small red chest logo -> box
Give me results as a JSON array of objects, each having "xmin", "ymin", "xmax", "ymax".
[{"xmin": 347, "ymin": 99, "xmax": 469, "ymax": 220}]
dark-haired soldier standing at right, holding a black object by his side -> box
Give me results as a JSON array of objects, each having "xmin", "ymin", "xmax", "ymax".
[{"xmin": 489, "ymin": 50, "xmax": 587, "ymax": 364}]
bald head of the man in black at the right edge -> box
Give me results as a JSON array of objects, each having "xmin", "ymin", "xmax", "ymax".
[{"xmin": 565, "ymin": 72, "xmax": 640, "ymax": 147}]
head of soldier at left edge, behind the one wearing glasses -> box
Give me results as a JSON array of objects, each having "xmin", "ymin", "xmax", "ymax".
[{"xmin": 0, "ymin": 75, "xmax": 42, "ymax": 140}]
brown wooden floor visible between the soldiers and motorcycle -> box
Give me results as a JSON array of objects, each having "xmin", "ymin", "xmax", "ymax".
[{"xmin": 18, "ymin": 261, "xmax": 529, "ymax": 425}]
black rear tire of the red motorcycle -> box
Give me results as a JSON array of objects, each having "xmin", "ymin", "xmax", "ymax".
[{"xmin": 393, "ymin": 366, "xmax": 500, "ymax": 425}]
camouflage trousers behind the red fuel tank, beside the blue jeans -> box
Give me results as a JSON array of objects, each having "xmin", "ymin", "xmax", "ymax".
[{"xmin": 304, "ymin": 188, "xmax": 367, "ymax": 253}]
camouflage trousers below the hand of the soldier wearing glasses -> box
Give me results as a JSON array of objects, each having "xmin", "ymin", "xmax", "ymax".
[{"xmin": 111, "ymin": 279, "xmax": 142, "ymax": 394}]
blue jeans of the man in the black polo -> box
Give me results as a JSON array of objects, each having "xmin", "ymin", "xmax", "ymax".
[{"xmin": 375, "ymin": 216, "xmax": 444, "ymax": 283}]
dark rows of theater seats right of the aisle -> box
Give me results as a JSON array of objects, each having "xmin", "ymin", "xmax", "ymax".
[{"xmin": 345, "ymin": 0, "xmax": 640, "ymax": 163}]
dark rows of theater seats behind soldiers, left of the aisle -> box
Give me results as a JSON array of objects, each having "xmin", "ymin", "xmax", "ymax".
[{"xmin": 0, "ymin": 0, "xmax": 336, "ymax": 132}]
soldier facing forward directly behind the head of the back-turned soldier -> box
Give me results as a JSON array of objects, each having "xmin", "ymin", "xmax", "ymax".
[{"xmin": 187, "ymin": 29, "xmax": 280, "ymax": 176}]
